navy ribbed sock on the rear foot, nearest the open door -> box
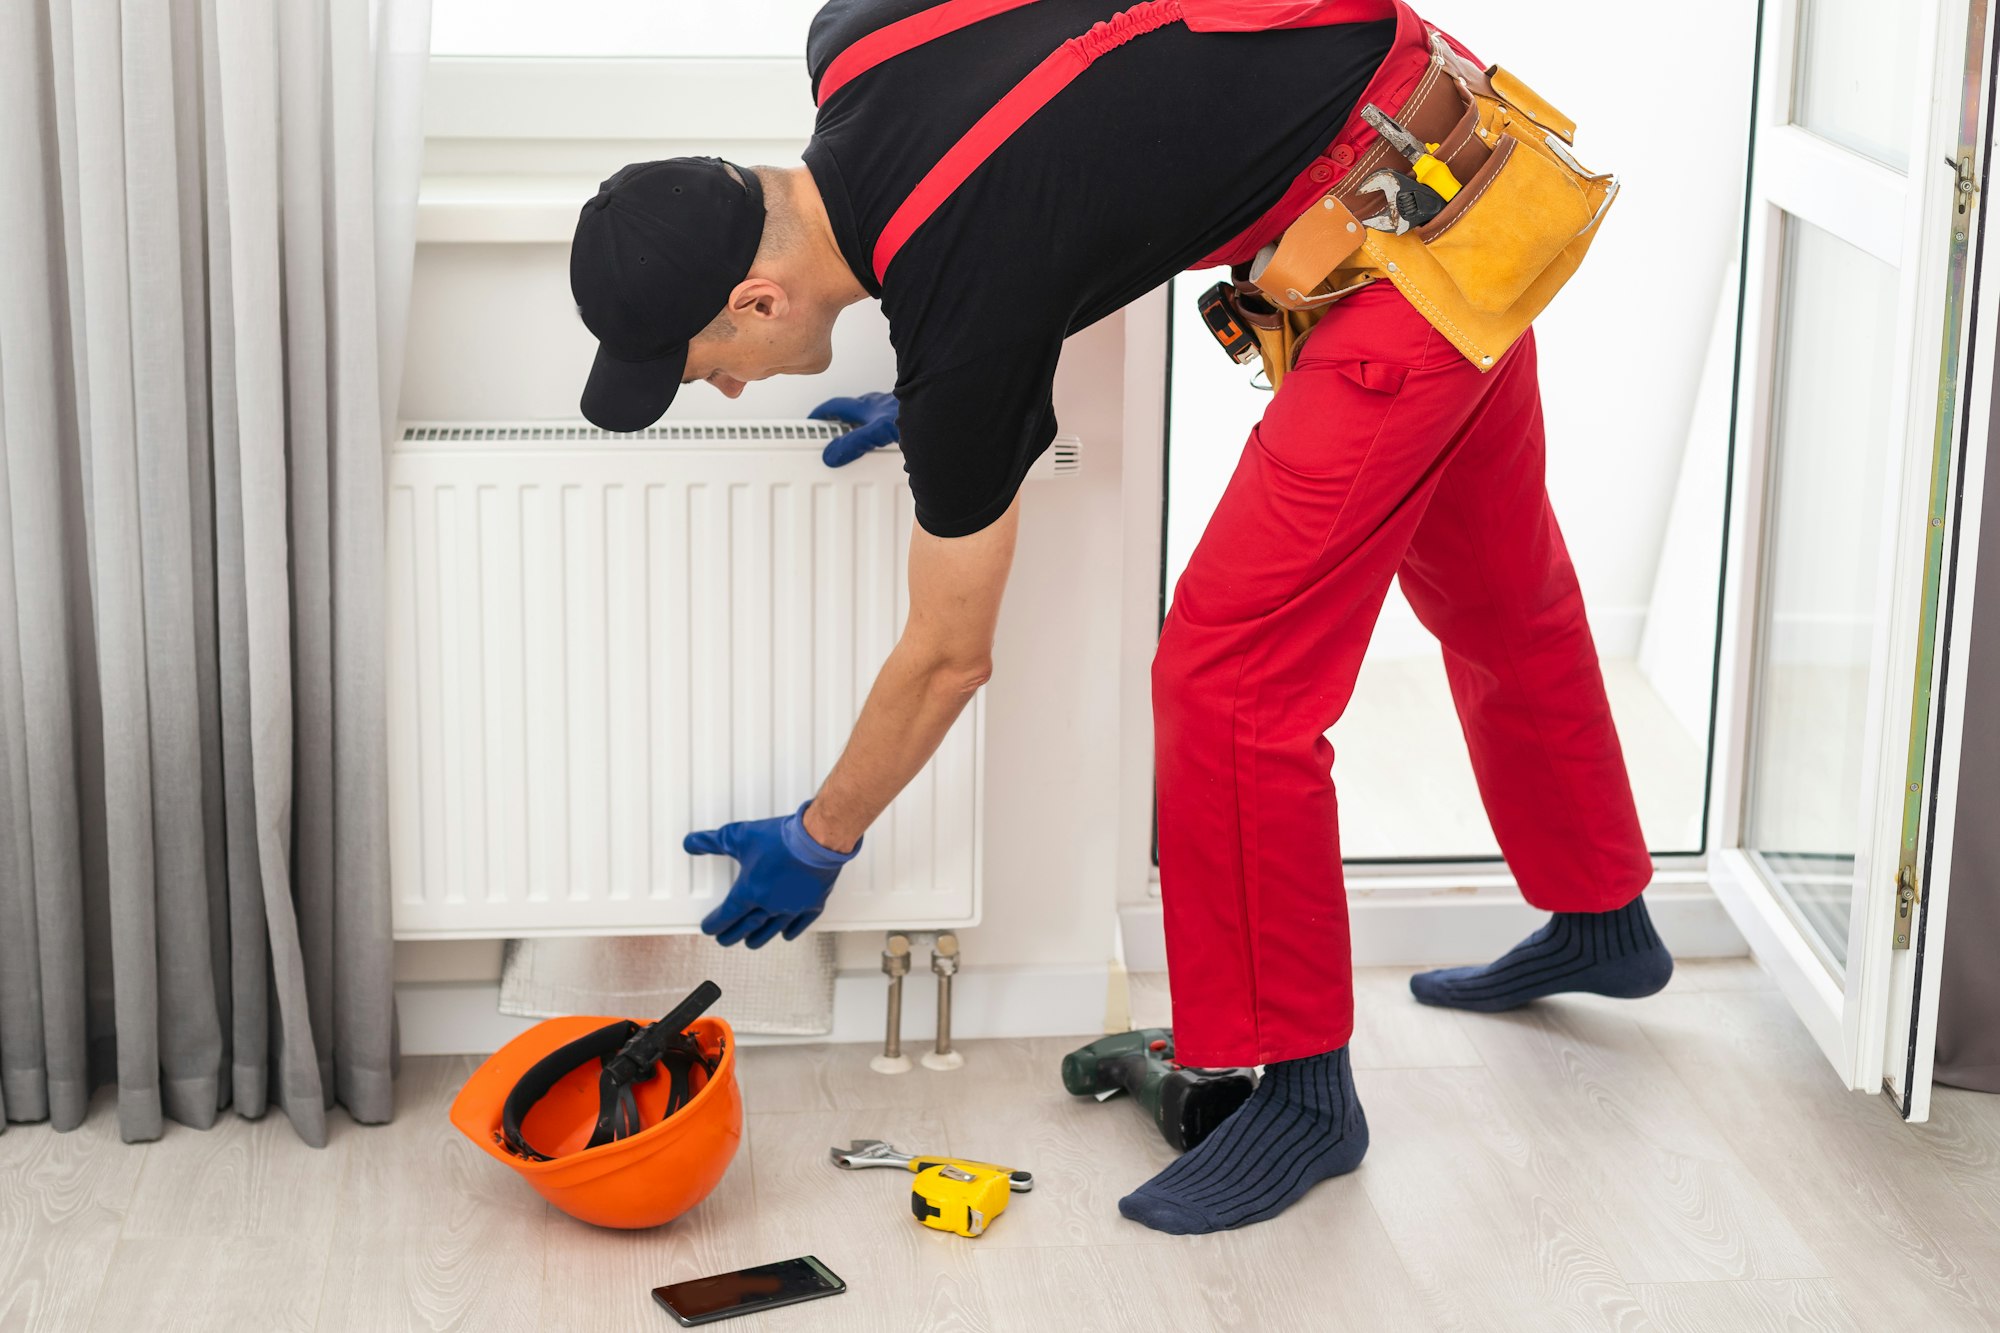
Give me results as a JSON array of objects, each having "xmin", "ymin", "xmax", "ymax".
[{"xmin": 1410, "ymin": 895, "xmax": 1674, "ymax": 1013}]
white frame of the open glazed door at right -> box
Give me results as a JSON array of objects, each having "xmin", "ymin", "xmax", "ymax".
[{"xmin": 1708, "ymin": 0, "xmax": 1984, "ymax": 1091}]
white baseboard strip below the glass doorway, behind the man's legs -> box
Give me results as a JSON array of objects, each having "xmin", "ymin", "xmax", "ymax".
[{"xmin": 1118, "ymin": 881, "xmax": 1750, "ymax": 973}]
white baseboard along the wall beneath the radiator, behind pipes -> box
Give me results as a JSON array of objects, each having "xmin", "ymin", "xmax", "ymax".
[{"xmin": 396, "ymin": 963, "xmax": 1122, "ymax": 1055}]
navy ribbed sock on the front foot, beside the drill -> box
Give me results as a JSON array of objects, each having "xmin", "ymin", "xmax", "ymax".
[{"xmin": 1118, "ymin": 1047, "xmax": 1368, "ymax": 1235}]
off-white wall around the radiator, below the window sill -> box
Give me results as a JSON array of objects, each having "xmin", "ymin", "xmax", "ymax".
[{"xmin": 398, "ymin": 114, "xmax": 1144, "ymax": 981}]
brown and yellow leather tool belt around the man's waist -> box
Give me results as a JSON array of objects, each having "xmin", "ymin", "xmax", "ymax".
[{"xmin": 1202, "ymin": 32, "xmax": 1618, "ymax": 388}]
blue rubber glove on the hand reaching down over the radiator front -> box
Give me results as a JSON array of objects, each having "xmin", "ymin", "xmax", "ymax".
[{"xmin": 680, "ymin": 801, "xmax": 862, "ymax": 949}]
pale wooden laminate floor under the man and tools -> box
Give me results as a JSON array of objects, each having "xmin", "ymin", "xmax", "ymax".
[{"xmin": 0, "ymin": 963, "xmax": 2000, "ymax": 1333}]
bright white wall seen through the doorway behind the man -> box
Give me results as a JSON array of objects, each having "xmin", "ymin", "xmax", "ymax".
[{"xmin": 1168, "ymin": 0, "xmax": 1756, "ymax": 656}]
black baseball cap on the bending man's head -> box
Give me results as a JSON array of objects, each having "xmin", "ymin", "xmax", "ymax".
[{"xmin": 570, "ymin": 158, "xmax": 764, "ymax": 430}]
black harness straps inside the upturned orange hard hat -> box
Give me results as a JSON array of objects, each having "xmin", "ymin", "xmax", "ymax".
[{"xmin": 494, "ymin": 981, "xmax": 722, "ymax": 1161}]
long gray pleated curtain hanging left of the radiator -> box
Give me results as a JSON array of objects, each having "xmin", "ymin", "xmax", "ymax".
[{"xmin": 0, "ymin": 0, "xmax": 428, "ymax": 1145}]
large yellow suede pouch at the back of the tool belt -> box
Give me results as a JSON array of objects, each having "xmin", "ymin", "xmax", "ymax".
[{"xmin": 1334, "ymin": 47, "xmax": 1618, "ymax": 370}]
